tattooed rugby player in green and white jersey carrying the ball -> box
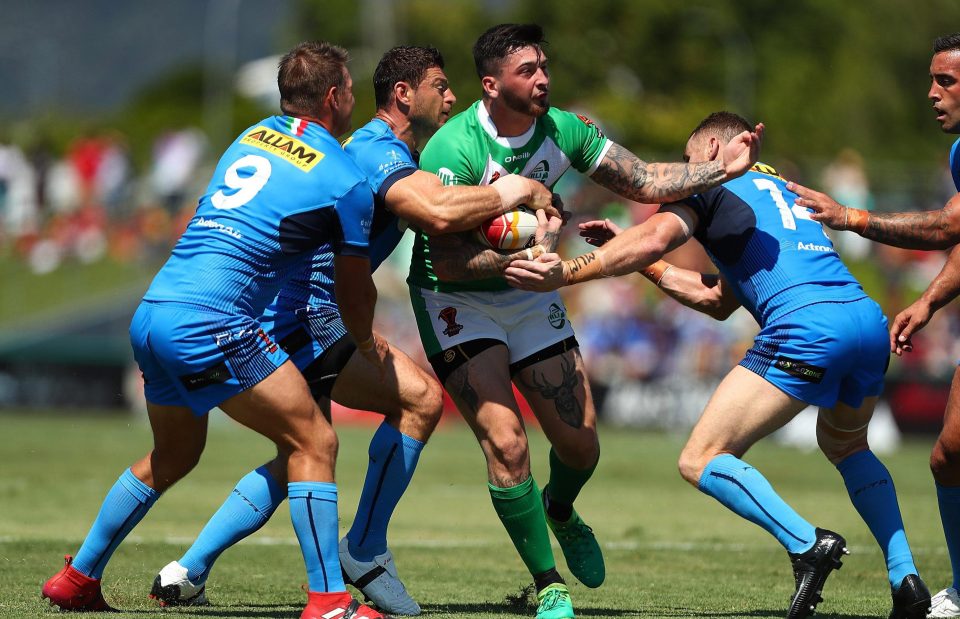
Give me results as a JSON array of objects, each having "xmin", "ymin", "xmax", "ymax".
[{"xmin": 408, "ymin": 24, "xmax": 762, "ymax": 619}]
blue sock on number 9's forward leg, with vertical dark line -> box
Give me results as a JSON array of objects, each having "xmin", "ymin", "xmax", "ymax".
[{"xmin": 287, "ymin": 481, "xmax": 347, "ymax": 593}]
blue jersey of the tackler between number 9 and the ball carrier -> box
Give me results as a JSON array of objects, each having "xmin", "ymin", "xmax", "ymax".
[{"xmin": 272, "ymin": 118, "xmax": 417, "ymax": 310}]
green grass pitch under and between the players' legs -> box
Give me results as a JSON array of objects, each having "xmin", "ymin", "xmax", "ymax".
[{"xmin": 0, "ymin": 413, "xmax": 949, "ymax": 619}]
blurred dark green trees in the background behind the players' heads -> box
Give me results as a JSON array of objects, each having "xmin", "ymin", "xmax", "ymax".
[{"xmin": 11, "ymin": 0, "xmax": 960, "ymax": 207}]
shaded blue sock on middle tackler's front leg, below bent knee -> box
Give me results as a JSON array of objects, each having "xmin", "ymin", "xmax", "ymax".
[{"xmin": 347, "ymin": 422, "xmax": 423, "ymax": 561}]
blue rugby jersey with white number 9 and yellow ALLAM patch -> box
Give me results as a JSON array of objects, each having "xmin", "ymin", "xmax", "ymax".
[{"xmin": 144, "ymin": 116, "xmax": 373, "ymax": 317}]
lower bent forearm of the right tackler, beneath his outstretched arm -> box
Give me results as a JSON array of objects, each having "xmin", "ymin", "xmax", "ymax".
[{"xmin": 640, "ymin": 260, "xmax": 740, "ymax": 320}]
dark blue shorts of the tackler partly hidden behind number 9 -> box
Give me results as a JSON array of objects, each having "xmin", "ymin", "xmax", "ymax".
[{"xmin": 260, "ymin": 303, "xmax": 356, "ymax": 400}]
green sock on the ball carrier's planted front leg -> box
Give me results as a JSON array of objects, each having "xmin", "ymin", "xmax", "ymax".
[{"xmin": 487, "ymin": 477, "xmax": 557, "ymax": 574}]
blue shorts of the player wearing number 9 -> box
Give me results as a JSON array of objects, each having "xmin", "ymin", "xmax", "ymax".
[{"xmin": 130, "ymin": 301, "xmax": 288, "ymax": 416}]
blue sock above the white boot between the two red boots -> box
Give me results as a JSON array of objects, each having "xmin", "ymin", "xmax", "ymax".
[{"xmin": 179, "ymin": 466, "xmax": 287, "ymax": 583}]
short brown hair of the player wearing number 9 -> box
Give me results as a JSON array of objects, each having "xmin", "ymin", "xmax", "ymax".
[{"xmin": 277, "ymin": 41, "xmax": 350, "ymax": 116}]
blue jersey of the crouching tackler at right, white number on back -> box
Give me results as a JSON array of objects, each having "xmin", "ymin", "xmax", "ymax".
[{"xmin": 681, "ymin": 164, "xmax": 866, "ymax": 326}]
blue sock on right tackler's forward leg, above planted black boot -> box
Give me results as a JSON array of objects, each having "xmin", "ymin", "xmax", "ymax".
[{"xmin": 699, "ymin": 454, "xmax": 817, "ymax": 553}]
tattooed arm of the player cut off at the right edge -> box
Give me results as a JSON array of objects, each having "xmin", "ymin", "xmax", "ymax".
[{"xmin": 863, "ymin": 207, "xmax": 960, "ymax": 249}]
